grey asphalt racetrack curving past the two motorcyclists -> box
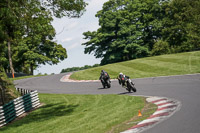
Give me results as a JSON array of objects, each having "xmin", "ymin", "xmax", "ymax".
[{"xmin": 15, "ymin": 74, "xmax": 200, "ymax": 133}]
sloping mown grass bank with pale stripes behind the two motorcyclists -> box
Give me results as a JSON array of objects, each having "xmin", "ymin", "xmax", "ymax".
[{"xmin": 70, "ymin": 51, "xmax": 200, "ymax": 80}]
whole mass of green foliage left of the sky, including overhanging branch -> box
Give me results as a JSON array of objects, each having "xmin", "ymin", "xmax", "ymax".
[{"xmin": 0, "ymin": 0, "xmax": 87, "ymax": 74}]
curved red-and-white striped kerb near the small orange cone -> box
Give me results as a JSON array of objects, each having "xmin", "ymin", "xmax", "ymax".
[{"xmin": 122, "ymin": 97, "xmax": 181, "ymax": 133}]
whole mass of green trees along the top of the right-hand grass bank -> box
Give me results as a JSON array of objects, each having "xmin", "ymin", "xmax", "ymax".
[{"xmin": 82, "ymin": 0, "xmax": 200, "ymax": 64}]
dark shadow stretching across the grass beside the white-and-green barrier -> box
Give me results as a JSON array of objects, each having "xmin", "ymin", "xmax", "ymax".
[{"xmin": 0, "ymin": 103, "xmax": 79, "ymax": 131}]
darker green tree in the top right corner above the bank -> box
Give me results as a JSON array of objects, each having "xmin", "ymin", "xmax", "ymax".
[{"xmin": 162, "ymin": 0, "xmax": 200, "ymax": 52}]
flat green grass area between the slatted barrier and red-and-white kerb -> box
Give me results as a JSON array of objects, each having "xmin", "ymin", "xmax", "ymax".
[{"xmin": 0, "ymin": 94, "xmax": 155, "ymax": 133}]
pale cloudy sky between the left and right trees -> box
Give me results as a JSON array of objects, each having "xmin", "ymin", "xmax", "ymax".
[{"xmin": 34, "ymin": 0, "xmax": 108, "ymax": 75}]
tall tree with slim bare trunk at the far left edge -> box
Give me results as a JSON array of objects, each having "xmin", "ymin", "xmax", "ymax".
[{"xmin": 0, "ymin": 0, "xmax": 23, "ymax": 74}]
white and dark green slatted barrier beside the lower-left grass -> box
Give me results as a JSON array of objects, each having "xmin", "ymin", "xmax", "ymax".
[{"xmin": 0, "ymin": 89, "xmax": 40, "ymax": 127}]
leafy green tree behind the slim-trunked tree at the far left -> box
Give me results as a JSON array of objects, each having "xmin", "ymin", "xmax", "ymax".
[{"xmin": 14, "ymin": 0, "xmax": 67, "ymax": 74}]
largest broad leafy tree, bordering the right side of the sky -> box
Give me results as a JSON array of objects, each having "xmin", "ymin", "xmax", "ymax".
[{"xmin": 82, "ymin": 0, "xmax": 162, "ymax": 64}]
